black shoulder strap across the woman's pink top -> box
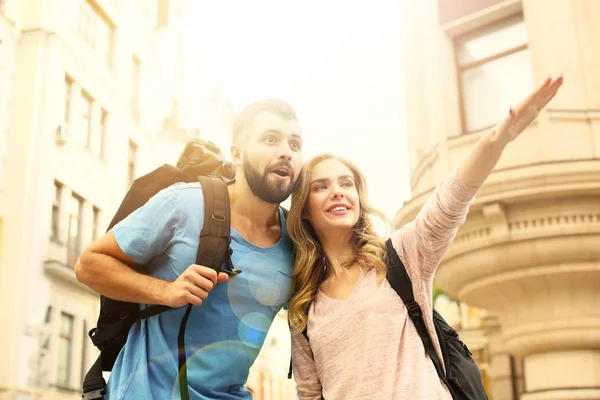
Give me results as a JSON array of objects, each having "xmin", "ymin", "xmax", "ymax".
[{"xmin": 385, "ymin": 239, "xmax": 445, "ymax": 379}]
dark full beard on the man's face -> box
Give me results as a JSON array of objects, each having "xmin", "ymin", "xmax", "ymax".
[{"xmin": 243, "ymin": 154, "xmax": 294, "ymax": 204}]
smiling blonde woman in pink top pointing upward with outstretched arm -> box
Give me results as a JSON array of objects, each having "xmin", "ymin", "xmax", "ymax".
[{"xmin": 288, "ymin": 76, "xmax": 563, "ymax": 400}]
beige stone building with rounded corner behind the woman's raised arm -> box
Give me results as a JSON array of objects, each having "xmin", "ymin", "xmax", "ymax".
[{"xmin": 395, "ymin": 0, "xmax": 600, "ymax": 400}]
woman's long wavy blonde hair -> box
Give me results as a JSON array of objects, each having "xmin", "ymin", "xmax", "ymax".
[{"xmin": 287, "ymin": 153, "xmax": 389, "ymax": 333}]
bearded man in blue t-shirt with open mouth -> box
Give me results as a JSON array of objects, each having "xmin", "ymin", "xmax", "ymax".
[{"xmin": 75, "ymin": 99, "xmax": 302, "ymax": 400}]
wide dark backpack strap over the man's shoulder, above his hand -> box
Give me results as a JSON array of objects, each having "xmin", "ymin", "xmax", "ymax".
[{"xmin": 196, "ymin": 176, "xmax": 231, "ymax": 272}]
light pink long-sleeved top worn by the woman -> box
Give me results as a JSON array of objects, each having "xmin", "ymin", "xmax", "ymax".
[{"xmin": 292, "ymin": 171, "xmax": 477, "ymax": 400}]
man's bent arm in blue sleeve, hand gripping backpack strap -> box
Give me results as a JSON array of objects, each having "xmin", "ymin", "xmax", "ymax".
[{"xmin": 75, "ymin": 184, "xmax": 227, "ymax": 307}]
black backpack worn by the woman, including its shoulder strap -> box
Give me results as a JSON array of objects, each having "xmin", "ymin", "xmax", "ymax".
[{"xmin": 288, "ymin": 239, "xmax": 488, "ymax": 400}]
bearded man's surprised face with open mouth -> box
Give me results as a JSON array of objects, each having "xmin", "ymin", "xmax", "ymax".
[{"xmin": 240, "ymin": 112, "xmax": 302, "ymax": 204}]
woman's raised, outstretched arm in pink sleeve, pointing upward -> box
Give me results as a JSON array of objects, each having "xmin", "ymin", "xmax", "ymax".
[{"xmin": 392, "ymin": 76, "xmax": 563, "ymax": 279}]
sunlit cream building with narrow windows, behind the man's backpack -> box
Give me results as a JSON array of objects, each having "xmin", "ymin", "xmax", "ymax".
[{"xmin": 0, "ymin": 0, "xmax": 213, "ymax": 400}]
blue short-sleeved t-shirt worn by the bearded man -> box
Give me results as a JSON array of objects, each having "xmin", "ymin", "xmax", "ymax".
[{"xmin": 106, "ymin": 183, "xmax": 293, "ymax": 400}]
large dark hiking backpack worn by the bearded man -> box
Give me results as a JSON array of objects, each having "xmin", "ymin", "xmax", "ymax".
[{"xmin": 82, "ymin": 139, "xmax": 239, "ymax": 399}]
